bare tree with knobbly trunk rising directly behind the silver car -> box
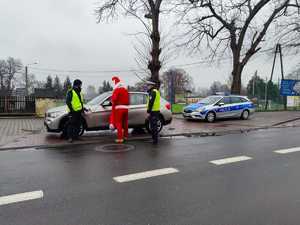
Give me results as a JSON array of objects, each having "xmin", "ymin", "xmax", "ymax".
[{"xmin": 96, "ymin": 0, "xmax": 173, "ymax": 83}]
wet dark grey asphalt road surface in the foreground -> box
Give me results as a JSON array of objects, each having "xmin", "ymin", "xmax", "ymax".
[{"xmin": 0, "ymin": 128, "xmax": 300, "ymax": 225}]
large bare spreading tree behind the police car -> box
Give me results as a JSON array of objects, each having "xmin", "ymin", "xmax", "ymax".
[{"xmin": 181, "ymin": 0, "xmax": 299, "ymax": 94}]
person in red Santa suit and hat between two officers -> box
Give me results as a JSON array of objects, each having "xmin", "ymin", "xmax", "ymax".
[{"xmin": 110, "ymin": 77, "xmax": 129, "ymax": 143}]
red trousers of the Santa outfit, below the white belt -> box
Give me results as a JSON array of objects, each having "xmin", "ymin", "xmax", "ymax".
[{"xmin": 115, "ymin": 109, "xmax": 128, "ymax": 139}]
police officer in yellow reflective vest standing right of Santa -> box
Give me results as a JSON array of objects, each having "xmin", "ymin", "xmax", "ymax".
[{"xmin": 146, "ymin": 81, "xmax": 160, "ymax": 144}]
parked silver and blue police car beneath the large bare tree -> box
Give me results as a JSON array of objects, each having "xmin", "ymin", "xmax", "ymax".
[{"xmin": 183, "ymin": 95, "xmax": 255, "ymax": 122}]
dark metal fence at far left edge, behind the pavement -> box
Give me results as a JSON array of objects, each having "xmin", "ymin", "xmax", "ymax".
[{"xmin": 0, "ymin": 96, "xmax": 35, "ymax": 115}]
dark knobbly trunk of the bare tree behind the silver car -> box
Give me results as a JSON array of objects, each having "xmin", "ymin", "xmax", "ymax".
[{"xmin": 148, "ymin": 9, "xmax": 161, "ymax": 84}]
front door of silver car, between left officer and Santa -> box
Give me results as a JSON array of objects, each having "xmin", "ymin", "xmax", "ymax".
[{"xmin": 87, "ymin": 96, "xmax": 112, "ymax": 128}]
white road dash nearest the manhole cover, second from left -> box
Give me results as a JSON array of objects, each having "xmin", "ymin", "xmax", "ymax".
[{"xmin": 113, "ymin": 168, "xmax": 179, "ymax": 183}]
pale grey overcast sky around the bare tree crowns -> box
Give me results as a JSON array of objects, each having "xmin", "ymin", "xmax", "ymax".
[{"xmin": 0, "ymin": 0, "xmax": 298, "ymax": 91}]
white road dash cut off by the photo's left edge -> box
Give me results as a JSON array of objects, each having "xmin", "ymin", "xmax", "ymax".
[{"xmin": 0, "ymin": 190, "xmax": 44, "ymax": 206}]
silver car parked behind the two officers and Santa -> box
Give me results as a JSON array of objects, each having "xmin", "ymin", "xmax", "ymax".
[{"xmin": 44, "ymin": 92, "xmax": 172, "ymax": 135}]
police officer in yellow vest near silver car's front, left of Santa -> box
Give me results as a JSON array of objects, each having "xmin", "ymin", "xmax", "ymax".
[{"xmin": 66, "ymin": 80, "xmax": 85, "ymax": 143}]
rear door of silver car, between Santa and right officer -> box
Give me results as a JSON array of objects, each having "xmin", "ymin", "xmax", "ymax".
[{"xmin": 128, "ymin": 92, "xmax": 147, "ymax": 127}]
